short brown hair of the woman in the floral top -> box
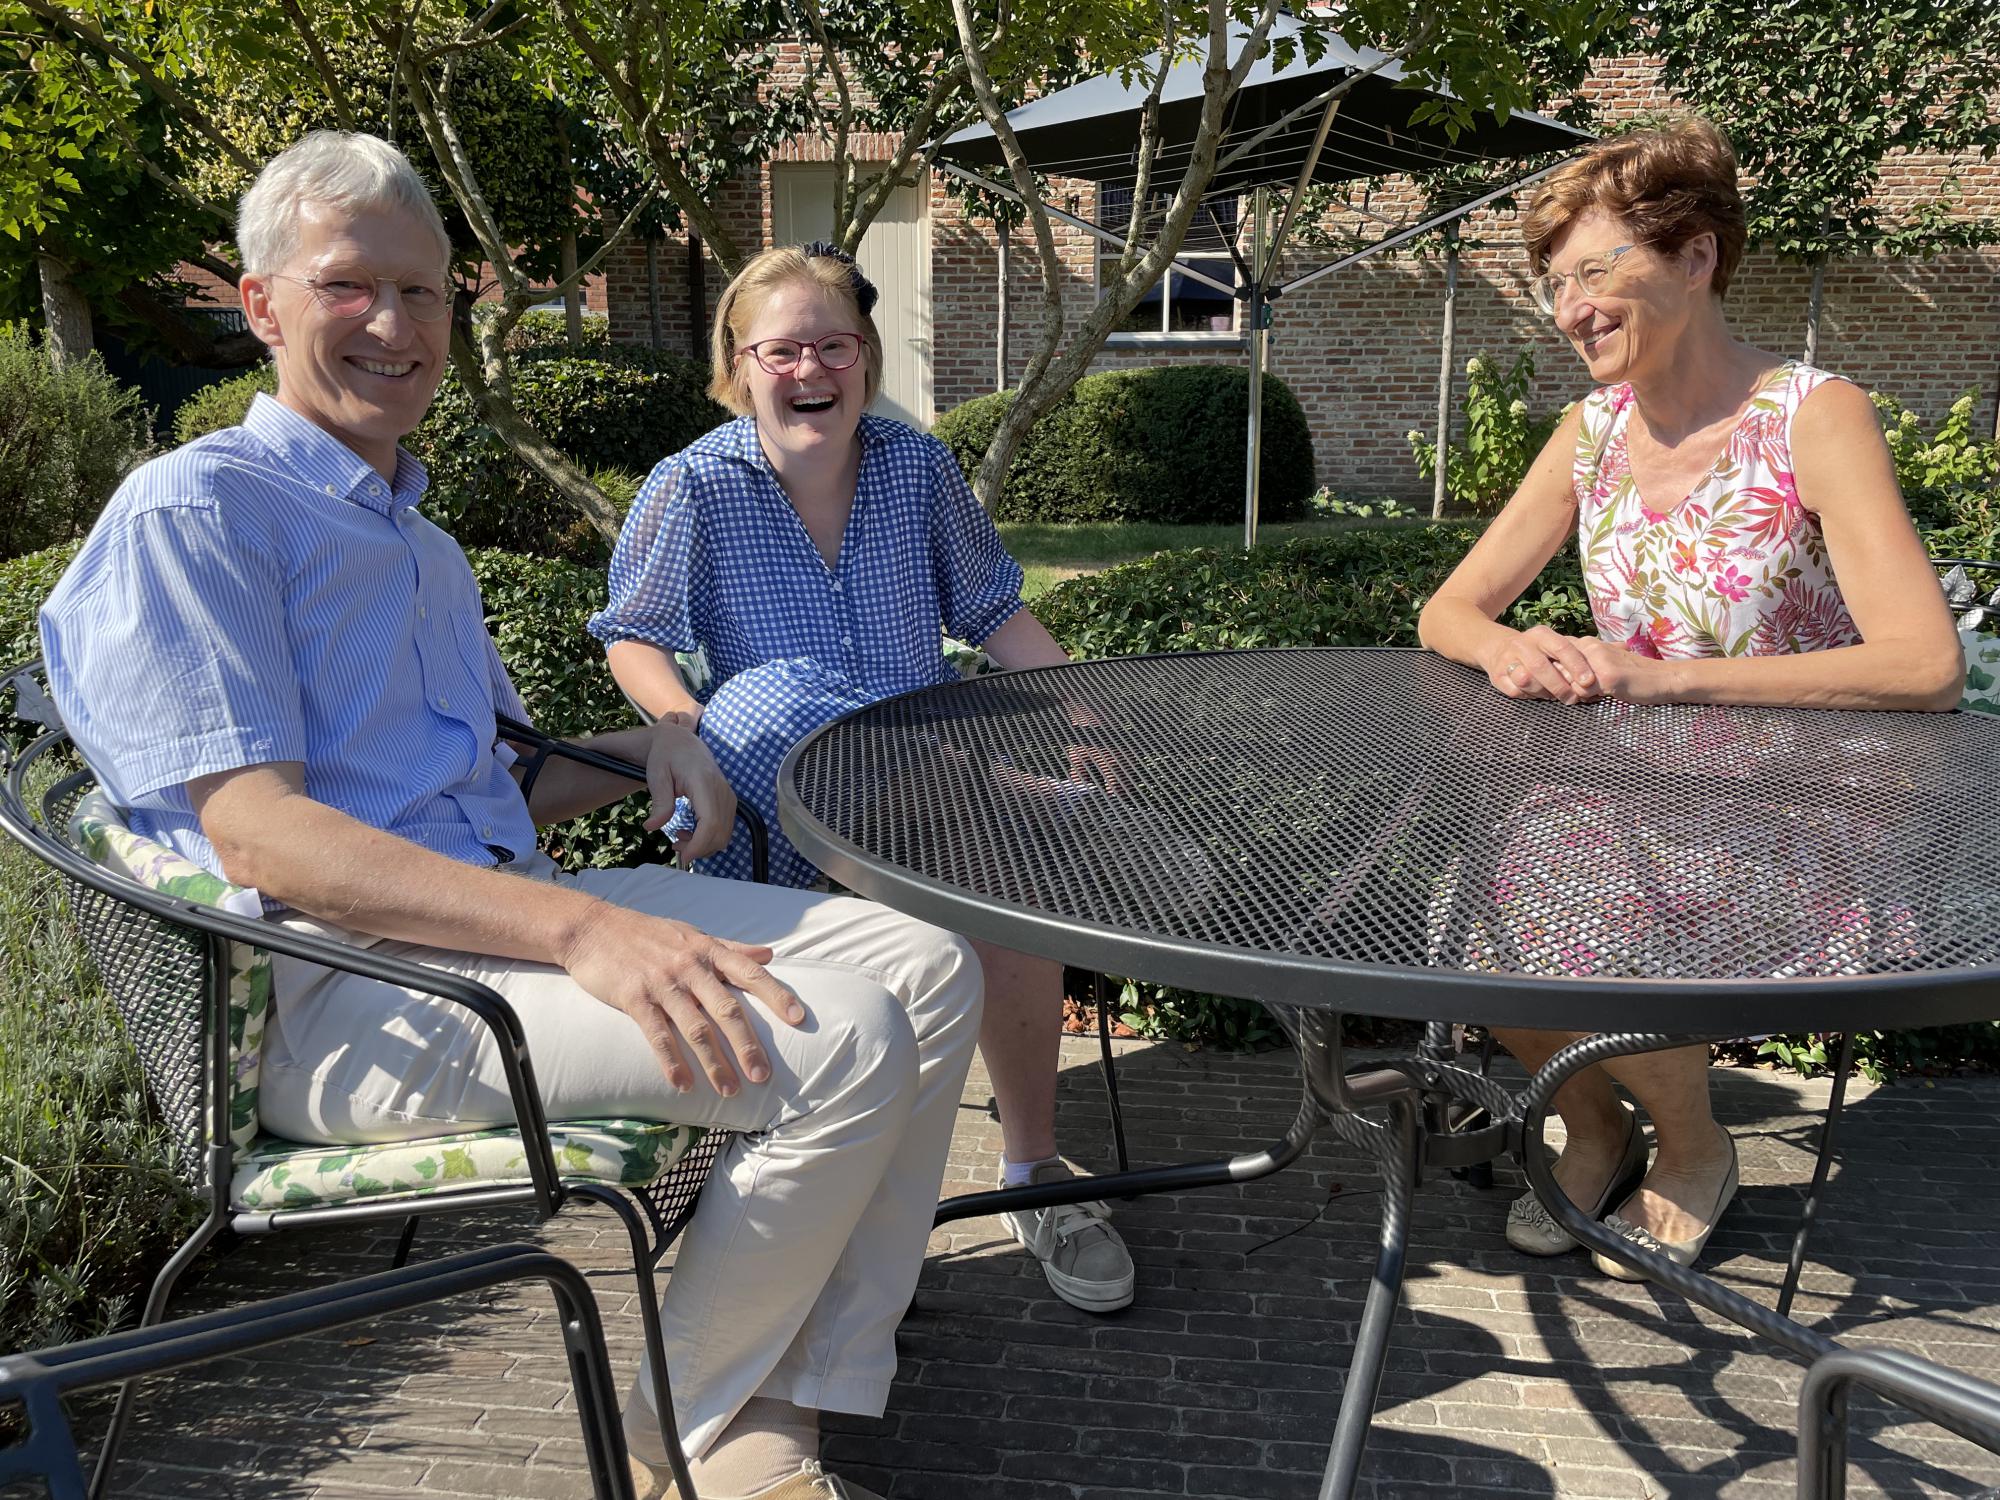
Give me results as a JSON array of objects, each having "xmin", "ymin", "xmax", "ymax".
[{"xmin": 1520, "ymin": 114, "xmax": 1746, "ymax": 298}]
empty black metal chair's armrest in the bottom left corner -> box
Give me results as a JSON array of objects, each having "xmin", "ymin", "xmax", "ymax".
[{"xmin": 0, "ymin": 1244, "xmax": 632, "ymax": 1500}]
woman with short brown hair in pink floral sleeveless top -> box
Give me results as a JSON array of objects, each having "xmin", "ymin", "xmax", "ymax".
[{"xmin": 1418, "ymin": 118, "xmax": 1964, "ymax": 1280}]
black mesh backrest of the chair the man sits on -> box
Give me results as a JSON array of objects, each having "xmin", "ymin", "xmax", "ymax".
[{"xmin": 44, "ymin": 784, "xmax": 208, "ymax": 1192}]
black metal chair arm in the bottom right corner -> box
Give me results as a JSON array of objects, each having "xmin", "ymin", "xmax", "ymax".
[{"xmin": 1798, "ymin": 1348, "xmax": 2000, "ymax": 1500}]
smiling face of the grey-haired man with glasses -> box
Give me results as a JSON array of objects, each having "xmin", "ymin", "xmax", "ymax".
[{"xmin": 242, "ymin": 204, "xmax": 452, "ymax": 480}]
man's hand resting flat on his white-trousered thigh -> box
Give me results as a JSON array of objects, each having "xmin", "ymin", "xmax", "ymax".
[{"xmin": 562, "ymin": 900, "xmax": 806, "ymax": 1098}]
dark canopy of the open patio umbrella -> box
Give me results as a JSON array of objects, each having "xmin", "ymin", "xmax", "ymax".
[{"xmin": 940, "ymin": 16, "xmax": 1592, "ymax": 194}]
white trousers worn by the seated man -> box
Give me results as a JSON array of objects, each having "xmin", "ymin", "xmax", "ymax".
[{"xmin": 260, "ymin": 862, "xmax": 982, "ymax": 1456}]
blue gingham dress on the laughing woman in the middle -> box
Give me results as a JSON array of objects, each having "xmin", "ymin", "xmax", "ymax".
[{"xmin": 590, "ymin": 416, "xmax": 1022, "ymax": 886}]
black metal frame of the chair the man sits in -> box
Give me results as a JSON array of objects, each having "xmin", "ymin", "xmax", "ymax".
[{"xmin": 0, "ymin": 662, "xmax": 762, "ymax": 1500}]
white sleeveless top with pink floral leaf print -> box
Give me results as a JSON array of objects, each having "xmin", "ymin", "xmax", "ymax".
[{"xmin": 1574, "ymin": 362, "xmax": 1860, "ymax": 658}]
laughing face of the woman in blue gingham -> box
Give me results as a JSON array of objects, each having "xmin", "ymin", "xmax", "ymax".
[{"xmin": 736, "ymin": 282, "xmax": 872, "ymax": 468}]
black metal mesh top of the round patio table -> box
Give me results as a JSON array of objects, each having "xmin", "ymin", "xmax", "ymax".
[{"xmin": 792, "ymin": 650, "xmax": 2000, "ymax": 980}]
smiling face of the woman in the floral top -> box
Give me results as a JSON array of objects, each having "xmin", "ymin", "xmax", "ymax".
[{"xmin": 1548, "ymin": 212, "xmax": 1714, "ymax": 386}]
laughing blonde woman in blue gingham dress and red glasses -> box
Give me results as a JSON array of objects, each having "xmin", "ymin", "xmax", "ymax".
[{"xmin": 590, "ymin": 244, "xmax": 1132, "ymax": 1312}]
